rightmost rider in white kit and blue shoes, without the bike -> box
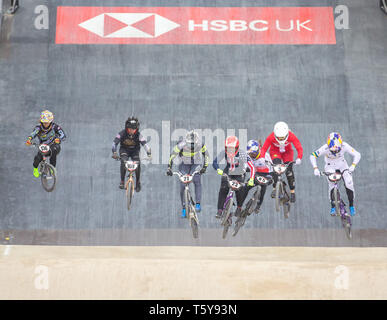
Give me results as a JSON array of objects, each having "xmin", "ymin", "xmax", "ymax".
[{"xmin": 310, "ymin": 132, "xmax": 361, "ymax": 216}]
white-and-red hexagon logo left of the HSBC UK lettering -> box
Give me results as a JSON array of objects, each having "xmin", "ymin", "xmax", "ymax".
[{"xmin": 79, "ymin": 13, "xmax": 180, "ymax": 38}]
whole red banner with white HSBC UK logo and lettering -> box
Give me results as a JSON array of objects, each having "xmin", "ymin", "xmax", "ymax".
[{"xmin": 56, "ymin": 7, "xmax": 336, "ymax": 45}]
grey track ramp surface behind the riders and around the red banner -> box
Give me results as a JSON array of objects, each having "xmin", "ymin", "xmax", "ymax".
[{"xmin": 0, "ymin": 0, "xmax": 387, "ymax": 246}]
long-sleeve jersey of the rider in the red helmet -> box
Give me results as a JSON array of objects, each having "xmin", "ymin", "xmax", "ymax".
[{"xmin": 212, "ymin": 151, "xmax": 255, "ymax": 178}]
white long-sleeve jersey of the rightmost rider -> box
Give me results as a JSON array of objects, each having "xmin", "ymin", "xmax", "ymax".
[{"xmin": 309, "ymin": 141, "xmax": 361, "ymax": 168}]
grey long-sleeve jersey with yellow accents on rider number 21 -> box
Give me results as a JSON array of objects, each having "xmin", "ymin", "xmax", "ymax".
[{"xmin": 168, "ymin": 140, "xmax": 209, "ymax": 168}]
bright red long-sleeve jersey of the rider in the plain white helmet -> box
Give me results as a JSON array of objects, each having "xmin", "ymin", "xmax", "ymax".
[{"xmin": 261, "ymin": 130, "xmax": 303, "ymax": 162}]
